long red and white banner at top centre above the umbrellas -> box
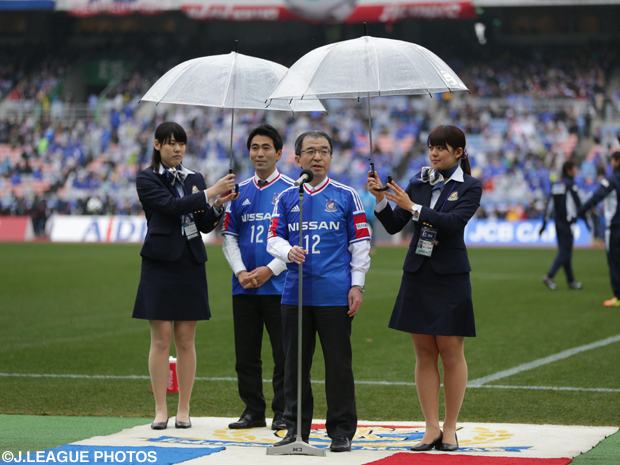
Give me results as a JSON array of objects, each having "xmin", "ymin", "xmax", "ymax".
[{"xmin": 180, "ymin": 0, "xmax": 477, "ymax": 23}]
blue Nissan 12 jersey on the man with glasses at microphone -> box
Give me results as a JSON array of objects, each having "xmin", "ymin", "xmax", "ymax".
[{"xmin": 269, "ymin": 179, "xmax": 370, "ymax": 306}]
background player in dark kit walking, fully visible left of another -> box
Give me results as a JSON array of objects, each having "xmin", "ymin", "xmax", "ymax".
[{"xmin": 539, "ymin": 161, "xmax": 583, "ymax": 291}]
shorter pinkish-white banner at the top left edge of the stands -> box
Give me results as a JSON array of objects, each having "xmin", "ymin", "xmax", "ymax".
[{"xmin": 56, "ymin": 0, "xmax": 179, "ymax": 16}]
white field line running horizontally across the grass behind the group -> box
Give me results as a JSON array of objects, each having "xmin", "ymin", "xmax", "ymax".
[{"xmin": 0, "ymin": 373, "xmax": 620, "ymax": 392}]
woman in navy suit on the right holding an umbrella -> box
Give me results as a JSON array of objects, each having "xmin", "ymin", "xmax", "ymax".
[{"xmin": 368, "ymin": 126, "xmax": 482, "ymax": 451}]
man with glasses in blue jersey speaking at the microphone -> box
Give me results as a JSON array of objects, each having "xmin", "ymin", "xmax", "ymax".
[{"xmin": 267, "ymin": 131, "xmax": 370, "ymax": 452}]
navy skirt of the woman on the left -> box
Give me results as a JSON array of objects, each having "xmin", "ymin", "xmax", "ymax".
[{"xmin": 133, "ymin": 243, "xmax": 211, "ymax": 321}]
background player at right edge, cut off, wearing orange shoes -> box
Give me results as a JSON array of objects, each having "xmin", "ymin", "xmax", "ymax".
[{"xmin": 577, "ymin": 151, "xmax": 620, "ymax": 307}]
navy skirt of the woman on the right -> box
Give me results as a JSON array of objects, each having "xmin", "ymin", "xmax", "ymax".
[{"xmin": 389, "ymin": 260, "xmax": 476, "ymax": 337}]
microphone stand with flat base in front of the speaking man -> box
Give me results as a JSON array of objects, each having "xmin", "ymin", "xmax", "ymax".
[{"xmin": 267, "ymin": 183, "xmax": 327, "ymax": 457}]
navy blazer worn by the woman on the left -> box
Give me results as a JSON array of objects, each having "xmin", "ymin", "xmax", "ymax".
[{"xmin": 136, "ymin": 167, "xmax": 222, "ymax": 263}]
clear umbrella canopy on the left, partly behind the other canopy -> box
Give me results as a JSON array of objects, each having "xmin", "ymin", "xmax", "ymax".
[{"xmin": 141, "ymin": 52, "xmax": 325, "ymax": 111}]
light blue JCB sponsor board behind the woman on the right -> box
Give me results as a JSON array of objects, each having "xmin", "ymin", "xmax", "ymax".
[{"xmin": 465, "ymin": 220, "xmax": 590, "ymax": 247}]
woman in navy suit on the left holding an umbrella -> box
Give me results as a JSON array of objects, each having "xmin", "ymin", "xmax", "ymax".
[{"xmin": 133, "ymin": 123, "xmax": 235, "ymax": 429}]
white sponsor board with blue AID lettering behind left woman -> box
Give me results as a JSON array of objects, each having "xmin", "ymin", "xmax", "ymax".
[{"xmin": 50, "ymin": 215, "xmax": 215, "ymax": 243}]
